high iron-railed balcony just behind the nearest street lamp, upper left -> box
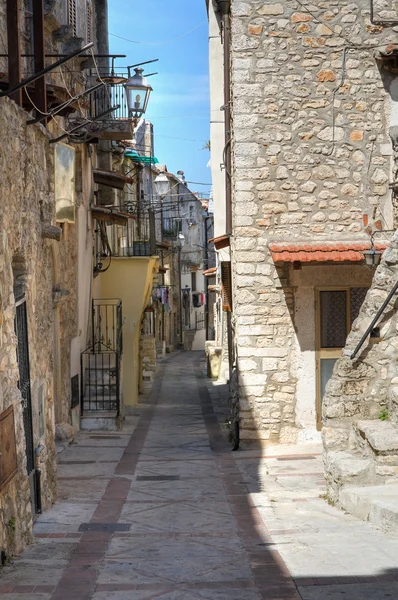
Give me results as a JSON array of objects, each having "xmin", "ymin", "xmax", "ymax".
[{"xmin": 90, "ymin": 73, "xmax": 134, "ymax": 140}]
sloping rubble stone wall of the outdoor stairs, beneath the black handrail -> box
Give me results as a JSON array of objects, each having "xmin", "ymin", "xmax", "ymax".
[{"xmin": 322, "ymin": 234, "xmax": 398, "ymax": 501}]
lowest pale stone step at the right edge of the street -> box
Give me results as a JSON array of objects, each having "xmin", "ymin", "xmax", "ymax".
[{"xmin": 339, "ymin": 482, "xmax": 398, "ymax": 534}]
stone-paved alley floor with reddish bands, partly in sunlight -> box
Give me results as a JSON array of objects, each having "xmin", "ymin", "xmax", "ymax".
[{"xmin": 0, "ymin": 353, "xmax": 398, "ymax": 600}]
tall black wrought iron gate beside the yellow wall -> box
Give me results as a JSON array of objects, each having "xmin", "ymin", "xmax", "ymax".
[{"xmin": 81, "ymin": 298, "xmax": 123, "ymax": 415}]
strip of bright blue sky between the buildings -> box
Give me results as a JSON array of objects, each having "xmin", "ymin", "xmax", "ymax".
[{"xmin": 108, "ymin": 0, "xmax": 210, "ymax": 197}]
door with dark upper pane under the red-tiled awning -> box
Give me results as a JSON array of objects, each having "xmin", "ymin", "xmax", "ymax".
[{"xmin": 316, "ymin": 287, "xmax": 368, "ymax": 429}]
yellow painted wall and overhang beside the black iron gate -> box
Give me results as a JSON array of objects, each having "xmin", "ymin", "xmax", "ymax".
[{"xmin": 93, "ymin": 256, "xmax": 158, "ymax": 406}]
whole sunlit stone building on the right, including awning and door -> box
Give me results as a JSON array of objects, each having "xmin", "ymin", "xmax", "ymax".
[{"xmin": 208, "ymin": 0, "xmax": 398, "ymax": 443}]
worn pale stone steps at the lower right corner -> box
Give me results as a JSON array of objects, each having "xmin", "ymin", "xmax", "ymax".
[{"xmin": 325, "ymin": 419, "xmax": 398, "ymax": 532}]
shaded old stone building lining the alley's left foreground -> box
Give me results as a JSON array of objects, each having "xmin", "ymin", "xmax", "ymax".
[{"xmin": 0, "ymin": 0, "xmax": 119, "ymax": 561}]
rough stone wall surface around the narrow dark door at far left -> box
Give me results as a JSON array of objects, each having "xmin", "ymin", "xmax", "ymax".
[{"xmin": 0, "ymin": 99, "xmax": 56, "ymax": 555}]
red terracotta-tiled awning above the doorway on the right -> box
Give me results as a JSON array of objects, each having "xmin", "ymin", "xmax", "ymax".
[{"xmin": 269, "ymin": 241, "xmax": 388, "ymax": 263}]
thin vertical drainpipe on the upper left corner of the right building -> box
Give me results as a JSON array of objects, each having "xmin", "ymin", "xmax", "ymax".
[{"xmin": 215, "ymin": 0, "xmax": 232, "ymax": 235}]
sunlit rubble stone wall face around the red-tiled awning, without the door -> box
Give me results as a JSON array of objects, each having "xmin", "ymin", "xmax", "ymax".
[{"xmin": 231, "ymin": 0, "xmax": 396, "ymax": 442}]
